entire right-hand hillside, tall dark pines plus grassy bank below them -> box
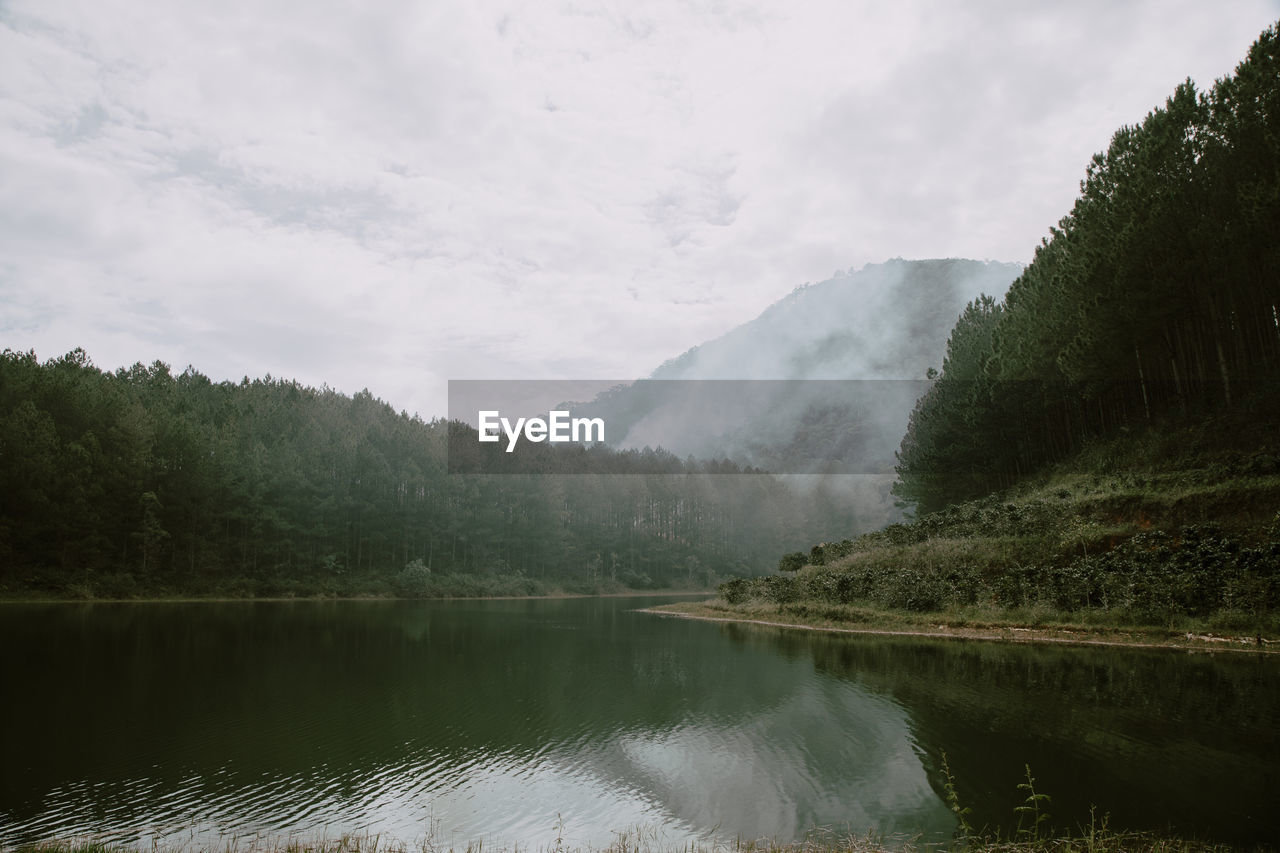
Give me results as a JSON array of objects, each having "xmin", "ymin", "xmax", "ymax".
[{"xmin": 696, "ymin": 19, "xmax": 1280, "ymax": 640}]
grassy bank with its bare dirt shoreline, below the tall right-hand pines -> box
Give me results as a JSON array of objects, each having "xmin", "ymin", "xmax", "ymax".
[{"xmin": 664, "ymin": 420, "xmax": 1280, "ymax": 649}]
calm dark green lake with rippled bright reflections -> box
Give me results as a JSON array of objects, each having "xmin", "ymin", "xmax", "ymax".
[{"xmin": 0, "ymin": 598, "xmax": 1280, "ymax": 848}]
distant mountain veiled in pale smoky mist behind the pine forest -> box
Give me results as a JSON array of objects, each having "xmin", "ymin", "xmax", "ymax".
[{"xmin": 575, "ymin": 259, "xmax": 1023, "ymax": 474}]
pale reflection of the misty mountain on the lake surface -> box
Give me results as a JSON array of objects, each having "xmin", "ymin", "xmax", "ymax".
[{"xmin": 608, "ymin": 680, "xmax": 954, "ymax": 839}]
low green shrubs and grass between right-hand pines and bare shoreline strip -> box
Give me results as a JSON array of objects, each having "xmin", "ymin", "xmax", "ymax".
[{"xmin": 722, "ymin": 432, "xmax": 1280, "ymax": 625}]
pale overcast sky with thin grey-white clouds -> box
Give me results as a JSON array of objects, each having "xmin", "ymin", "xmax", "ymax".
[{"xmin": 0, "ymin": 0, "xmax": 1280, "ymax": 418}]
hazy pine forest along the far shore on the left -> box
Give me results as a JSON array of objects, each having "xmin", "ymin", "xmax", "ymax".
[{"xmin": 0, "ymin": 350, "xmax": 849, "ymax": 594}]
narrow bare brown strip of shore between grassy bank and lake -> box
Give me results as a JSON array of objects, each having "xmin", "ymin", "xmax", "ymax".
[{"xmin": 636, "ymin": 602, "xmax": 1280, "ymax": 654}]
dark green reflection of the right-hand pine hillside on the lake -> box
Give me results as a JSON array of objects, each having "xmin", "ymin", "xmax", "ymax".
[{"xmin": 727, "ymin": 617, "xmax": 1280, "ymax": 845}]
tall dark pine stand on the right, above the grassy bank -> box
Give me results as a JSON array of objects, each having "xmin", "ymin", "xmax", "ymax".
[{"xmin": 896, "ymin": 26, "xmax": 1280, "ymax": 511}]
